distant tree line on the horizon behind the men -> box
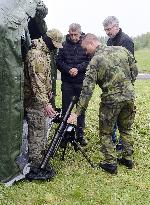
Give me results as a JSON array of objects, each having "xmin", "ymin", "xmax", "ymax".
[{"xmin": 99, "ymin": 32, "xmax": 150, "ymax": 50}]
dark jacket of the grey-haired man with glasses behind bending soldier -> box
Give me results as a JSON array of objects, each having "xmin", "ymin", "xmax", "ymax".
[{"xmin": 107, "ymin": 28, "xmax": 134, "ymax": 55}]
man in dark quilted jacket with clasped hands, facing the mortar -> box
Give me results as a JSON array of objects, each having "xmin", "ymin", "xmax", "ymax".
[{"xmin": 56, "ymin": 23, "xmax": 90, "ymax": 146}]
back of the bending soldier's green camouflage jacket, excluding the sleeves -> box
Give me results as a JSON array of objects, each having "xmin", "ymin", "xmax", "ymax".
[{"xmin": 97, "ymin": 46, "xmax": 134, "ymax": 102}]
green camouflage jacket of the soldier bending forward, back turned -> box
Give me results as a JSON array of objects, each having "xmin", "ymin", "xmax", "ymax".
[{"xmin": 76, "ymin": 46, "xmax": 138, "ymax": 114}]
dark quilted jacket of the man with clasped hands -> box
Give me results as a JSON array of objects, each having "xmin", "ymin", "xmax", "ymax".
[{"xmin": 56, "ymin": 35, "xmax": 90, "ymax": 83}]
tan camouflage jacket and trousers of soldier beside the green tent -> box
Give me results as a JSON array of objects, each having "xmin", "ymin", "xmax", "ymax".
[{"xmin": 25, "ymin": 38, "xmax": 51, "ymax": 167}]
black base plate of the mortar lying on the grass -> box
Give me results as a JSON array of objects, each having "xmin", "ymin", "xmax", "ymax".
[{"xmin": 25, "ymin": 167, "xmax": 56, "ymax": 181}]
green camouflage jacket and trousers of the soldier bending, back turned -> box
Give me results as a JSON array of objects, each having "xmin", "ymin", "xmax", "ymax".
[{"xmin": 76, "ymin": 46, "xmax": 138, "ymax": 164}]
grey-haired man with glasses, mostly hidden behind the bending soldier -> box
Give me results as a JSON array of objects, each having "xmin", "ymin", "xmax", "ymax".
[{"xmin": 103, "ymin": 16, "xmax": 136, "ymax": 150}]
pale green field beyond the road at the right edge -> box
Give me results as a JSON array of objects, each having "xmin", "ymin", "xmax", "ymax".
[{"xmin": 135, "ymin": 48, "xmax": 150, "ymax": 73}]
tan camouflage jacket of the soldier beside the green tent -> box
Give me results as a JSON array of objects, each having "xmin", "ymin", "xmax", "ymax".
[{"xmin": 24, "ymin": 38, "xmax": 51, "ymax": 107}]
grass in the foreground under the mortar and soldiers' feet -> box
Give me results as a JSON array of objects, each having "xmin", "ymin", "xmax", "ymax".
[{"xmin": 0, "ymin": 80, "xmax": 150, "ymax": 205}]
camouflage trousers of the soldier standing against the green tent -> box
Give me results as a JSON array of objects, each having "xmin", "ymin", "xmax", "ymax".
[{"xmin": 27, "ymin": 107, "xmax": 47, "ymax": 167}]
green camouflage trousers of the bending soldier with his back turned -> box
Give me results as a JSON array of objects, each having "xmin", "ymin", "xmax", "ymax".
[{"xmin": 99, "ymin": 101, "xmax": 136, "ymax": 163}]
